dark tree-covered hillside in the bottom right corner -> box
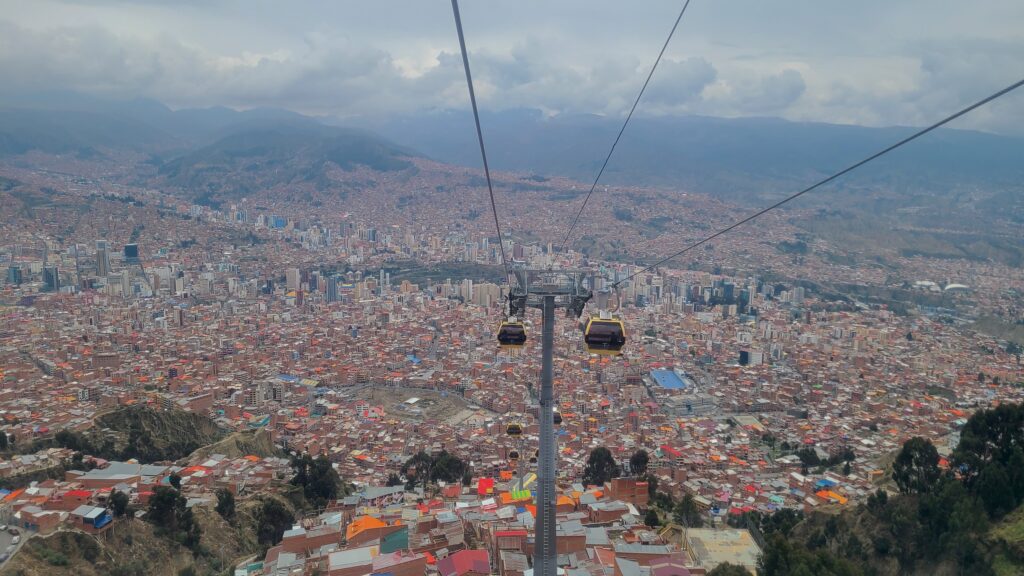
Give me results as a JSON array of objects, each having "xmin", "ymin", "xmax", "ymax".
[{"xmin": 748, "ymin": 404, "xmax": 1024, "ymax": 576}]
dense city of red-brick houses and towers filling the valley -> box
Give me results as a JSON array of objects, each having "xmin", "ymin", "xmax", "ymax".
[{"xmin": 0, "ymin": 140, "xmax": 1024, "ymax": 576}]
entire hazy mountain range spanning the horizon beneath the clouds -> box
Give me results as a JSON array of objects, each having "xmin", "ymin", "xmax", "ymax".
[{"xmin": 0, "ymin": 92, "xmax": 1024, "ymax": 229}]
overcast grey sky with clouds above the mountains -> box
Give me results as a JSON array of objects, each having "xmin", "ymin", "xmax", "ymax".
[{"xmin": 0, "ymin": 0, "xmax": 1024, "ymax": 134}]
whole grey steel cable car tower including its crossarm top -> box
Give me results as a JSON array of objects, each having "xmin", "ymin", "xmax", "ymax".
[{"xmin": 509, "ymin": 270, "xmax": 591, "ymax": 576}]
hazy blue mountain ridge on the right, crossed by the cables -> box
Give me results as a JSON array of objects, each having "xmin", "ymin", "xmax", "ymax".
[{"xmin": 355, "ymin": 110, "xmax": 1024, "ymax": 200}]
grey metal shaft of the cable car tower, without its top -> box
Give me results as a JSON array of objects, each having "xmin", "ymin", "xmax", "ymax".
[{"xmin": 534, "ymin": 294, "xmax": 557, "ymax": 576}]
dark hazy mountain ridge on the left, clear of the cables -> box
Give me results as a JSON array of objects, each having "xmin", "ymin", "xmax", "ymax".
[{"xmin": 0, "ymin": 93, "xmax": 421, "ymax": 205}]
